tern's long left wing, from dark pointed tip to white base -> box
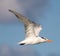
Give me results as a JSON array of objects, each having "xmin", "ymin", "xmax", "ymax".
[{"xmin": 9, "ymin": 10, "xmax": 35, "ymax": 37}]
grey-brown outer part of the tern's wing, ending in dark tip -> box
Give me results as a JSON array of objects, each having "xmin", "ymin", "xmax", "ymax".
[{"xmin": 9, "ymin": 10, "xmax": 31, "ymax": 25}]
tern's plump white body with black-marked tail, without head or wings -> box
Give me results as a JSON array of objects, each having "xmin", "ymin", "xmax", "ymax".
[{"xmin": 18, "ymin": 37, "xmax": 44, "ymax": 44}]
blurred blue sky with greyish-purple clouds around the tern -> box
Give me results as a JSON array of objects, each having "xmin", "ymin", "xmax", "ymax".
[{"xmin": 0, "ymin": 0, "xmax": 60, "ymax": 56}]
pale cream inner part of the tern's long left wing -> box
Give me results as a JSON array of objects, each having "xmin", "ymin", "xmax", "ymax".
[{"xmin": 25, "ymin": 24, "xmax": 36, "ymax": 38}]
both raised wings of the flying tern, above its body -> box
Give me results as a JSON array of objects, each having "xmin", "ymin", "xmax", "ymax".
[{"xmin": 9, "ymin": 10, "xmax": 42, "ymax": 37}]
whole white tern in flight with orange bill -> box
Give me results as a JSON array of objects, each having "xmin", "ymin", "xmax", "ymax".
[{"xmin": 9, "ymin": 10, "xmax": 52, "ymax": 45}]
